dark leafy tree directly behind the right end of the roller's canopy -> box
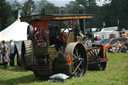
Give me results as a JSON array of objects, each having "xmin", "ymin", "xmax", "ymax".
[{"xmin": 70, "ymin": 0, "xmax": 99, "ymax": 28}]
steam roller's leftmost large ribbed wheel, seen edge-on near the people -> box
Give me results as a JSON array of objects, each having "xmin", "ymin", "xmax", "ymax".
[{"xmin": 21, "ymin": 40, "xmax": 33, "ymax": 70}]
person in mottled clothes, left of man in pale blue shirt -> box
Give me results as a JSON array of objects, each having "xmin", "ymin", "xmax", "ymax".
[{"xmin": 2, "ymin": 41, "xmax": 10, "ymax": 69}]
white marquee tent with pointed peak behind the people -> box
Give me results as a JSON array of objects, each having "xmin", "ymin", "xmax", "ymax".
[{"xmin": 0, "ymin": 19, "xmax": 28, "ymax": 41}]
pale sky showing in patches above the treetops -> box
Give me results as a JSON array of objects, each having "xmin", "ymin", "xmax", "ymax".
[{"xmin": 6, "ymin": 0, "xmax": 108, "ymax": 6}]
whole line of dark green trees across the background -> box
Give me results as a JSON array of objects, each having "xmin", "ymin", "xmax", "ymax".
[{"xmin": 0, "ymin": 0, "xmax": 128, "ymax": 31}]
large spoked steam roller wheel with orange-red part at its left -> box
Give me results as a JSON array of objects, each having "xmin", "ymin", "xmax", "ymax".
[{"xmin": 65, "ymin": 42, "xmax": 87, "ymax": 77}]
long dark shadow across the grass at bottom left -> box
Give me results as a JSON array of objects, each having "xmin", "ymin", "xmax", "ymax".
[{"xmin": 0, "ymin": 75, "xmax": 42, "ymax": 85}]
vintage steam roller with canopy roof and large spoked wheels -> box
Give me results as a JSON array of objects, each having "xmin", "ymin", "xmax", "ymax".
[{"xmin": 21, "ymin": 14, "xmax": 108, "ymax": 79}]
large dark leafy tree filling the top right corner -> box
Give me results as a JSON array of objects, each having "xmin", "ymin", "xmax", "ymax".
[{"xmin": 96, "ymin": 0, "xmax": 128, "ymax": 30}]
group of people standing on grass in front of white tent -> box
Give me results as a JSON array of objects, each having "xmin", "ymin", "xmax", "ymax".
[{"xmin": 0, "ymin": 40, "xmax": 17, "ymax": 69}]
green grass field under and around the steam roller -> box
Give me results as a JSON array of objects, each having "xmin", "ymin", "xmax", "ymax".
[{"xmin": 0, "ymin": 53, "xmax": 128, "ymax": 85}]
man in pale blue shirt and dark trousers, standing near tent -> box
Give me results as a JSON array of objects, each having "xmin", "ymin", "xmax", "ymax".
[{"xmin": 9, "ymin": 40, "xmax": 15, "ymax": 66}]
